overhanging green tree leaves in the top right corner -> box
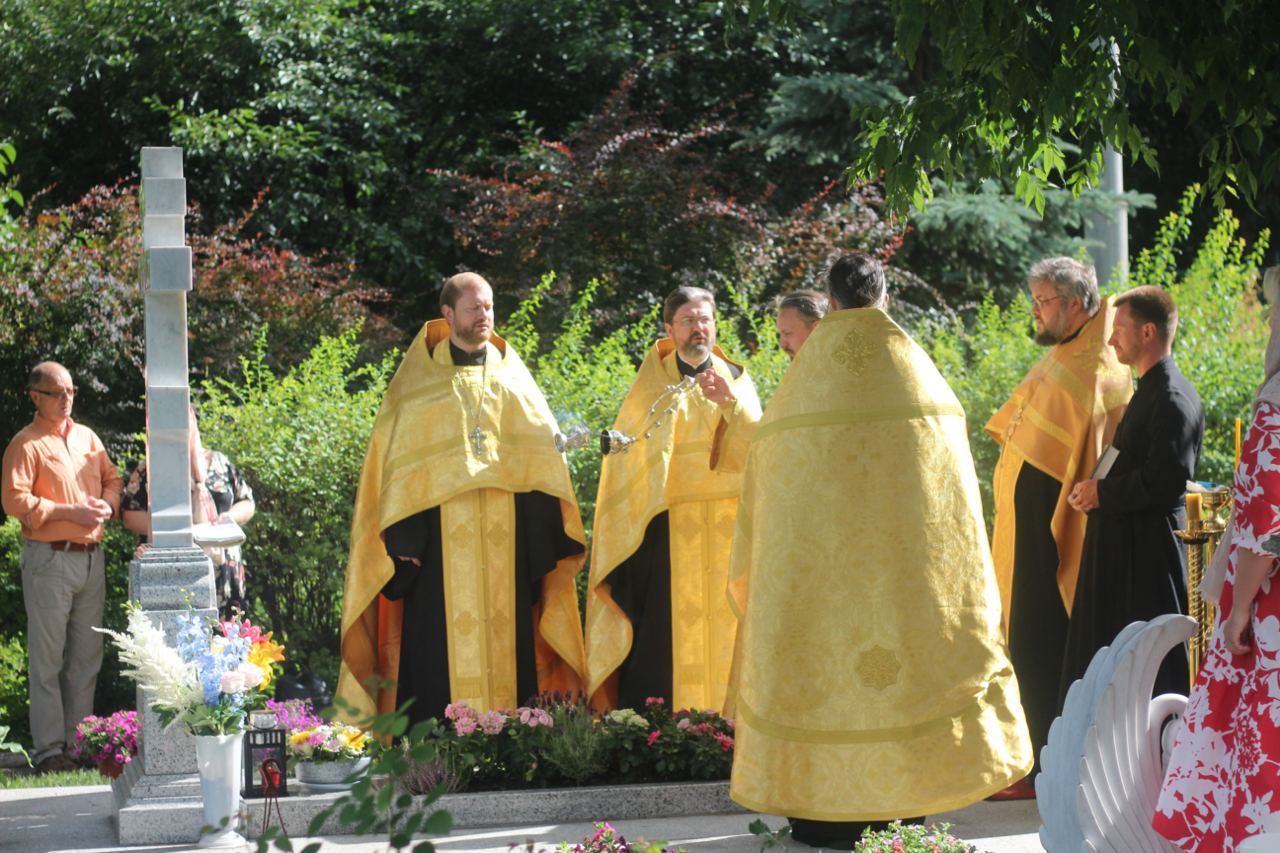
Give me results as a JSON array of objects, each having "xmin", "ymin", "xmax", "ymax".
[{"xmin": 748, "ymin": 0, "xmax": 1280, "ymax": 211}]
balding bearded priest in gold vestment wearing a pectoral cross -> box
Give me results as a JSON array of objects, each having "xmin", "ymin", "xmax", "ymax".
[{"xmin": 338, "ymin": 273, "xmax": 586, "ymax": 721}]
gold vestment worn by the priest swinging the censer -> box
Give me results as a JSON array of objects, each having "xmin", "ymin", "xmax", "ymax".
[{"xmin": 586, "ymin": 338, "xmax": 760, "ymax": 711}]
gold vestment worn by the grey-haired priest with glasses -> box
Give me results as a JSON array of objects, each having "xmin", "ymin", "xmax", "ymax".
[{"xmin": 986, "ymin": 297, "xmax": 1133, "ymax": 630}]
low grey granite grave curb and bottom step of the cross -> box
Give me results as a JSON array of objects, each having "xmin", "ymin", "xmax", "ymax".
[{"xmin": 113, "ymin": 762, "xmax": 746, "ymax": 845}]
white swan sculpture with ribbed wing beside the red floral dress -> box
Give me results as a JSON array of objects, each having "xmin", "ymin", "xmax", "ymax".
[{"xmin": 1036, "ymin": 613, "xmax": 1196, "ymax": 853}]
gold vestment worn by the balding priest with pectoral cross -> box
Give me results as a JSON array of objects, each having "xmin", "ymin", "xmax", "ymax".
[{"xmin": 338, "ymin": 320, "xmax": 586, "ymax": 715}]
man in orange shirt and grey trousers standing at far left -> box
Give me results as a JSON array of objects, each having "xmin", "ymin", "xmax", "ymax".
[{"xmin": 0, "ymin": 361, "xmax": 122, "ymax": 772}]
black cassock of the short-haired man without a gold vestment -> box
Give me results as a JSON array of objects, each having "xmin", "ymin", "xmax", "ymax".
[{"xmin": 1059, "ymin": 359, "xmax": 1204, "ymax": 708}]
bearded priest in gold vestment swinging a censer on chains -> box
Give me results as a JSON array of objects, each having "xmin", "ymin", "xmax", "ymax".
[{"xmin": 586, "ymin": 287, "xmax": 760, "ymax": 711}]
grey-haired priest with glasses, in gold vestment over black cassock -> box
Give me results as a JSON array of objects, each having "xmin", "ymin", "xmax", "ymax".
[{"xmin": 986, "ymin": 257, "xmax": 1133, "ymax": 798}]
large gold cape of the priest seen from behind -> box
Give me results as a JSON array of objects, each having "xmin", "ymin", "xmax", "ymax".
[{"xmin": 730, "ymin": 309, "xmax": 1032, "ymax": 821}]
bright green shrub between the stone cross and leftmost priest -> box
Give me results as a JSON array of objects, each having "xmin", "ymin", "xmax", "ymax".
[{"xmin": 200, "ymin": 328, "xmax": 398, "ymax": 688}]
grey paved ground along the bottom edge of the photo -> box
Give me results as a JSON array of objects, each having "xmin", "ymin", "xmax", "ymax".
[{"xmin": 0, "ymin": 785, "xmax": 1042, "ymax": 853}]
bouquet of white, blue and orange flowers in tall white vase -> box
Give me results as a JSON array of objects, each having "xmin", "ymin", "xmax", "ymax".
[{"xmin": 96, "ymin": 605, "xmax": 284, "ymax": 735}]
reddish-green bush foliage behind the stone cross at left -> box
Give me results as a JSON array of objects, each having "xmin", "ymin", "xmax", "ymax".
[{"xmin": 0, "ymin": 184, "xmax": 388, "ymax": 450}]
